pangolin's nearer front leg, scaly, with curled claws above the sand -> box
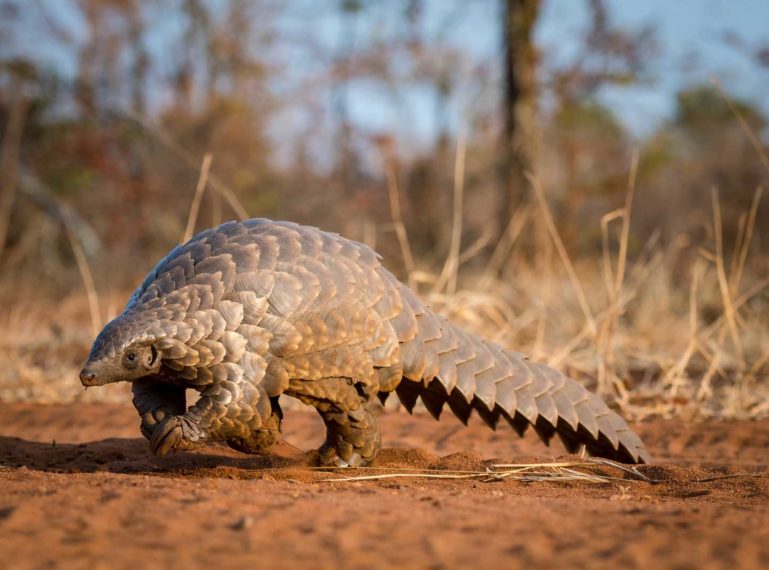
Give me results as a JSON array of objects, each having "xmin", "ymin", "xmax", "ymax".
[{"xmin": 150, "ymin": 381, "xmax": 280, "ymax": 456}]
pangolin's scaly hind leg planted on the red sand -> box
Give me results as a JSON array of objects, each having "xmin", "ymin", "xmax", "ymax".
[{"xmin": 287, "ymin": 378, "xmax": 382, "ymax": 467}]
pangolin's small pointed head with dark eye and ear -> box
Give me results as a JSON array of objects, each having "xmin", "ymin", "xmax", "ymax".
[{"xmin": 80, "ymin": 313, "xmax": 163, "ymax": 387}]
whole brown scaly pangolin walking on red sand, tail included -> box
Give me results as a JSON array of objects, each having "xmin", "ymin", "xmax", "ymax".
[{"xmin": 80, "ymin": 219, "xmax": 649, "ymax": 466}]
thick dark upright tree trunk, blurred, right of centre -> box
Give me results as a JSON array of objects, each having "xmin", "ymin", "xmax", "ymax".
[{"xmin": 497, "ymin": 0, "xmax": 540, "ymax": 232}]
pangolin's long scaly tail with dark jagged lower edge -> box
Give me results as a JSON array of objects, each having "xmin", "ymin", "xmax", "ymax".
[{"xmin": 381, "ymin": 294, "xmax": 649, "ymax": 463}]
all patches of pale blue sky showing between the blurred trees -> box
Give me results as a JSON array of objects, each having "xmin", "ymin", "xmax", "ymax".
[{"xmin": 7, "ymin": 0, "xmax": 769, "ymax": 144}]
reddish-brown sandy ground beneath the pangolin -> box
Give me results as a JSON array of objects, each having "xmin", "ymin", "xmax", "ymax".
[{"xmin": 0, "ymin": 404, "xmax": 769, "ymax": 569}]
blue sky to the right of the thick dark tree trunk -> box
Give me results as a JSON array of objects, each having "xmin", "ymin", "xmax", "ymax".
[{"xmin": 538, "ymin": 0, "xmax": 769, "ymax": 134}]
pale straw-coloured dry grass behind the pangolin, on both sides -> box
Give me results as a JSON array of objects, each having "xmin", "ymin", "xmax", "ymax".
[{"xmin": 0, "ymin": 161, "xmax": 769, "ymax": 418}]
